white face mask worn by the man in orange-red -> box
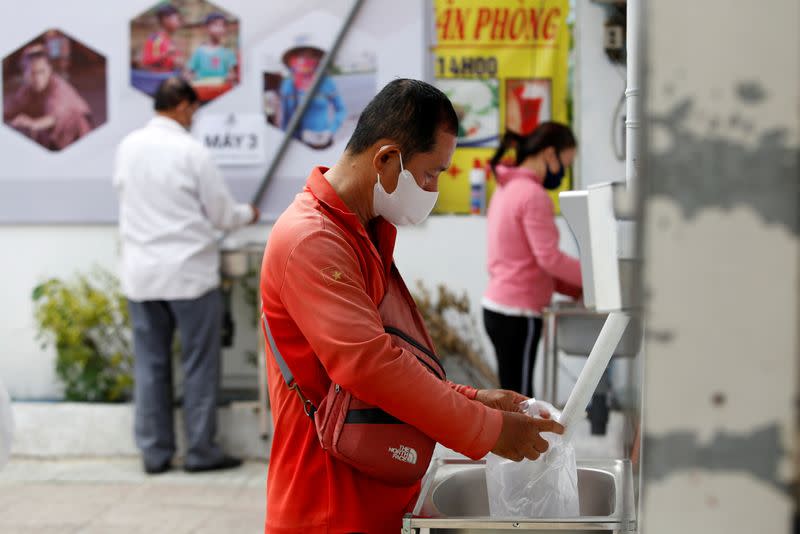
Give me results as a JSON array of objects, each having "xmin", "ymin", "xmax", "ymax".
[{"xmin": 372, "ymin": 154, "xmax": 439, "ymax": 225}]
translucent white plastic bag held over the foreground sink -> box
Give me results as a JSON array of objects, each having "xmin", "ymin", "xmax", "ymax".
[{"xmin": 486, "ymin": 399, "xmax": 580, "ymax": 518}]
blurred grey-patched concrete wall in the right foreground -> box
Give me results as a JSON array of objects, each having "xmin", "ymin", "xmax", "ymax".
[{"xmin": 640, "ymin": 0, "xmax": 800, "ymax": 534}]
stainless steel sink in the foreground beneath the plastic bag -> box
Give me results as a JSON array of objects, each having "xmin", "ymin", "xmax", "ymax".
[{"xmin": 404, "ymin": 459, "xmax": 635, "ymax": 534}]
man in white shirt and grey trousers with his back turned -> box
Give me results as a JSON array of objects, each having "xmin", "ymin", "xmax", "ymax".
[{"xmin": 114, "ymin": 78, "xmax": 259, "ymax": 474}]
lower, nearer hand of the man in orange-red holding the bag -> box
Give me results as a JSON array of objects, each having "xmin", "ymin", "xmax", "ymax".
[{"xmin": 492, "ymin": 412, "xmax": 564, "ymax": 462}]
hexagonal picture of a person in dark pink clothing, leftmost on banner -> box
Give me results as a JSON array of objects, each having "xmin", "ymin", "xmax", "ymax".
[{"xmin": 3, "ymin": 28, "xmax": 108, "ymax": 152}]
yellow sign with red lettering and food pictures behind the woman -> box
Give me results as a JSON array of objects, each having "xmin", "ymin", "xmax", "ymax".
[{"xmin": 431, "ymin": 0, "xmax": 571, "ymax": 213}]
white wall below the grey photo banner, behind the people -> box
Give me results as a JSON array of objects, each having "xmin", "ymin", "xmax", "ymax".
[{"xmin": 0, "ymin": 216, "xmax": 576, "ymax": 399}]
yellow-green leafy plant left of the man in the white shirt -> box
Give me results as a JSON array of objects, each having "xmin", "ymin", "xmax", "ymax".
[{"xmin": 32, "ymin": 269, "xmax": 133, "ymax": 401}]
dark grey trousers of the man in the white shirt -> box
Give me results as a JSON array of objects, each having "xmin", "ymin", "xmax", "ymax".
[{"xmin": 128, "ymin": 289, "xmax": 223, "ymax": 467}]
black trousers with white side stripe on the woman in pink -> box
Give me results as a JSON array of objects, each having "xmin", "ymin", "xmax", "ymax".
[{"xmin": 483, "ymin": 308, "xmax": 542, "ymax": 397}]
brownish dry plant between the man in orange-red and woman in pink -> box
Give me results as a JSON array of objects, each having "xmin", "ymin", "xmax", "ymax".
[{"xmin": 413, "ymin": 280, "xmax": 497, "ymax": 385}]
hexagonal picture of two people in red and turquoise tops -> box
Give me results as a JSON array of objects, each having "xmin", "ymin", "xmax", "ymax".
[{"xmin": 130, "ymin": 0, "xmax": 241, "ymax": 103}]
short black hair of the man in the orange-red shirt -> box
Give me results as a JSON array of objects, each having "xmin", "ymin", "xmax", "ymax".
[{"xmin": 347, "ymin": 78, "xmax": 458, "ymax": 159}]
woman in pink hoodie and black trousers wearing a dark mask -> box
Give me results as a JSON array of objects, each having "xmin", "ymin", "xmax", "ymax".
[{"xmin": 483, "ymin": 122, "xmax": 581, "ymax": 396}]
